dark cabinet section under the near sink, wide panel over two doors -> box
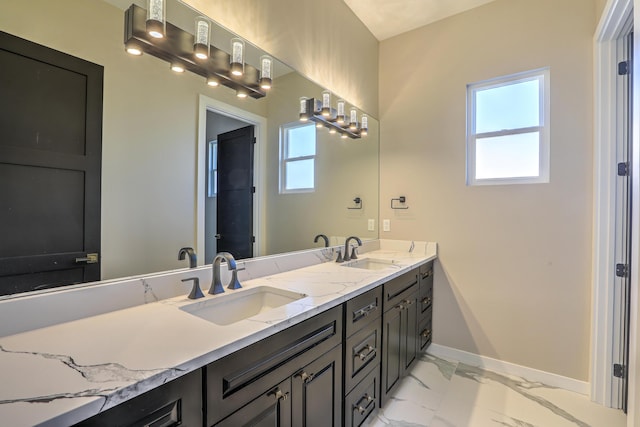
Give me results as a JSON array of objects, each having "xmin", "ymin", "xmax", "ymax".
[{"xmin": 204, "ymin": 306, "xmax": 342, "ymax": 426}]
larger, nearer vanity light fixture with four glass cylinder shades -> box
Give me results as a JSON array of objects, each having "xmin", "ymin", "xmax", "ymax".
[{"xmin": 124, "ymin": 4, "xmax": 268, "ymax": 99}]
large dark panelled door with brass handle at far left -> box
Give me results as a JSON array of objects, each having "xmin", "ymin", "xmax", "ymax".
[{"xmin": 0, "ymin": 32, "xmax": 103, "ymax": 295}]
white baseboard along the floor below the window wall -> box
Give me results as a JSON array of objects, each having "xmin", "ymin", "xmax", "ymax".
[{"xmin": 427, "ymin": 344, "xmax": 590, "ymax": 396}]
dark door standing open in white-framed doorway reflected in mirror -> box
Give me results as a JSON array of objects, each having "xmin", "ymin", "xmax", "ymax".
[{"xmin": 216, "ymin": 126, "xmax": 255, "ymax": 259}]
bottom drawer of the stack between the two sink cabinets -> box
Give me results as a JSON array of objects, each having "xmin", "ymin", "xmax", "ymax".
[{"xmin": 344, "ymin": 369, "xmax": 380, "ymax": 427}]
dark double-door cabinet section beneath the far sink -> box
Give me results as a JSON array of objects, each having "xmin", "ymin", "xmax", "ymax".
[{"xmin": 380, "ymin": 269, "xmax": 420, "ymax": 405}]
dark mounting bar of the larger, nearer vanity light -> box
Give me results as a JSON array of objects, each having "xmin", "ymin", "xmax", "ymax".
[{"xmin": 124, "ymin": 4, "xmax": 266, "ymax": 99}]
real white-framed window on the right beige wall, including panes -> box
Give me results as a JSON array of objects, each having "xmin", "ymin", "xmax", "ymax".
[{"xmin": 467, "ymin": 68, "xmax": 549, "ymax": 185}]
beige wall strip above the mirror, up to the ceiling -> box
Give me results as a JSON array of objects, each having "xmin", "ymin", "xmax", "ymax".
[{"xmin": 184, "ymin": 0, "xmax": 378, "ymax": 117}]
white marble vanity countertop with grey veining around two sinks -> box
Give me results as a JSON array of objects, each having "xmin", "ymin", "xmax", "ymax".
[{"xmin": 0, "ymin": 240, "xmax": 437, "ymax": 426}]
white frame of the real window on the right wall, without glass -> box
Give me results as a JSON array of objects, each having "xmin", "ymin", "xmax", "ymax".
[{"xmin": 466, "ymin": 67, "xmax": 551, "ymax": 186}]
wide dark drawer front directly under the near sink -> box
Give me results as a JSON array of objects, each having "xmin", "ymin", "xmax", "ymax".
[{"xmin": 206, "ymin": 306, "xmax": 342, "ymax": 425}]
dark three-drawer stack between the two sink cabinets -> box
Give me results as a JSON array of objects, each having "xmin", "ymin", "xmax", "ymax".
[{"xmin": 344, "ymin": 286, "xmax": 382, "ymax": 427}]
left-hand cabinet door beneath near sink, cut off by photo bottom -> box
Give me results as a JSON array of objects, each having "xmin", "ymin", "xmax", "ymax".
[{"xmin": 215, "ymin": 378, "xmax": 292, "ymax": 427}]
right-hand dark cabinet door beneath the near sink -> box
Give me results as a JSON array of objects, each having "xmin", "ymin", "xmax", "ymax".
[{"xmin": 291, "ymin": 345, "xmax": 342, "ymax": 427}]
